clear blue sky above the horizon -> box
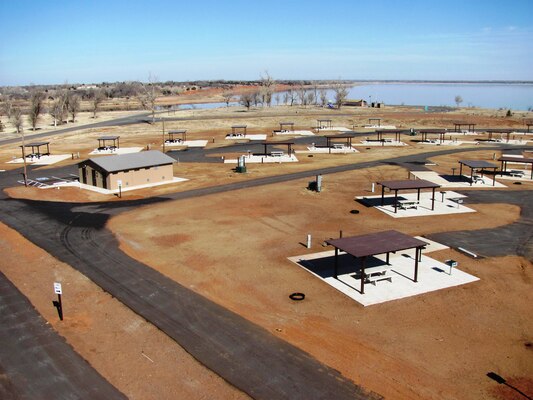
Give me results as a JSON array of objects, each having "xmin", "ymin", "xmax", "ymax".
[{"xmin": 0, "ymin": 0, "xmax": 533, "ymax": 85}]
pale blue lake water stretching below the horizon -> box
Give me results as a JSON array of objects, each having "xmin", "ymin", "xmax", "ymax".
[{"xmin": 166, "ymin": 83, "xmax": 533, "ymax": 110}]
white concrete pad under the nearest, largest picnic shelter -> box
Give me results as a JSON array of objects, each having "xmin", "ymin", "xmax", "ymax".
[{"xmin": 289, "ymin": 250, "xmax": 479, "ymax": 307}]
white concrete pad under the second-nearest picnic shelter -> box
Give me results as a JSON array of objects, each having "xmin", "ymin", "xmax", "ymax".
[{"xmin": 356, "ymin": 191, "xmax": 476, "ymax": 218}]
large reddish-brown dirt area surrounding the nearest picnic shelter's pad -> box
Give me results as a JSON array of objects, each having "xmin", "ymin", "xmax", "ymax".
[{"xmin": 109, "ymin": 166, "xmax": 533, "ymax": 399}]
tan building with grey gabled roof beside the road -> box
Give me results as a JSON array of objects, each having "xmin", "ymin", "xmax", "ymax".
[{"xmin": 78, "ymin": 150, "xmax": 176, "ymax": 190}]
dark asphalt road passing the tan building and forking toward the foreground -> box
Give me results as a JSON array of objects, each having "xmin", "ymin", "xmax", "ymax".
[{"xmin": 0, "ymin": 131, "xmax": 528, "ymax": 399}]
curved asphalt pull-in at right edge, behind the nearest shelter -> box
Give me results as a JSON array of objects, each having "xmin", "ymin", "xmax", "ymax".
[{"xmin": 428, "ymin": 190, "xmax": 533, "ymax": 261}]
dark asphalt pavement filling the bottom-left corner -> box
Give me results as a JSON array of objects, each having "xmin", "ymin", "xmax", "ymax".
[{"xmin": 0, "ymin": 272, "xmax": 126, "ymax": 399}]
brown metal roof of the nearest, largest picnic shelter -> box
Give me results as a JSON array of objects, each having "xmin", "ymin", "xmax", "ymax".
[{"xmin": 326, "ymin": 230, "xmax": 427, "ymax": 257}]
